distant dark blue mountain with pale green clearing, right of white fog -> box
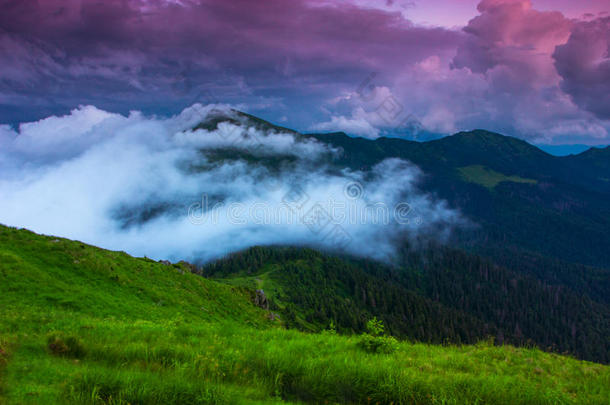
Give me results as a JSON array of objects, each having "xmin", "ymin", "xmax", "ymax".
[{"xmin": 201, "ymin": 111, "xmax": 610, "ymax": 292}]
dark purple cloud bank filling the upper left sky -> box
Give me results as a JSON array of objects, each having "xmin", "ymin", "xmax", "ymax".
[{"xmin": 0, "ymin": 0, "xmax": 459, "ymax": 122}]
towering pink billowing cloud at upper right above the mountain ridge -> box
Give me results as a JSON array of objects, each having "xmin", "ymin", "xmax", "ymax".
[{"xmin": 422, "ymin": 0, "xmax": 610, "ymax": 143}]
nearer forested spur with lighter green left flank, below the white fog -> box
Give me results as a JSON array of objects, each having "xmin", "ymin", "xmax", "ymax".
[{"xmin": 203, "ymin": 247, "xmax": 486, "ymax": 343}]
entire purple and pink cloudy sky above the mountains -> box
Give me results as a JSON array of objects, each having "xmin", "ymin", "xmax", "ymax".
[{"xmin": 0, "ymin": 0, "xmax": 610, "ymax": 145}]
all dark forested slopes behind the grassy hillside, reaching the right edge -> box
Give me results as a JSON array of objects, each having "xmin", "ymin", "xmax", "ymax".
[{"xmin": 203, "ymin": 247, "xmax": 610, "ymax": 362}]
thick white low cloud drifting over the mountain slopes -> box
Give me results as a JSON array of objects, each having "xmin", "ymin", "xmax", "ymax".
[{"xmin": 0, "ymin": 105, "xmax": 460, "ymax": 261}]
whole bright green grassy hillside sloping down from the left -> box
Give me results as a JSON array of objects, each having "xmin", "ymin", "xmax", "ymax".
[{"xmin": 0, "ymin": 227, "xmax": 610, "ymax": 404}]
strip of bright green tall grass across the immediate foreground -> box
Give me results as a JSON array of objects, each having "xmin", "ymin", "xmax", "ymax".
[{"xmin": 7, "ymin": 314, "xmax": 610, "ymax": 404}]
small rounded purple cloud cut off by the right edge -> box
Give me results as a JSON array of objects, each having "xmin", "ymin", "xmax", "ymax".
[{"xmin": 553, "ymin": 17, "xmax": 610, "ymax": 119}]
